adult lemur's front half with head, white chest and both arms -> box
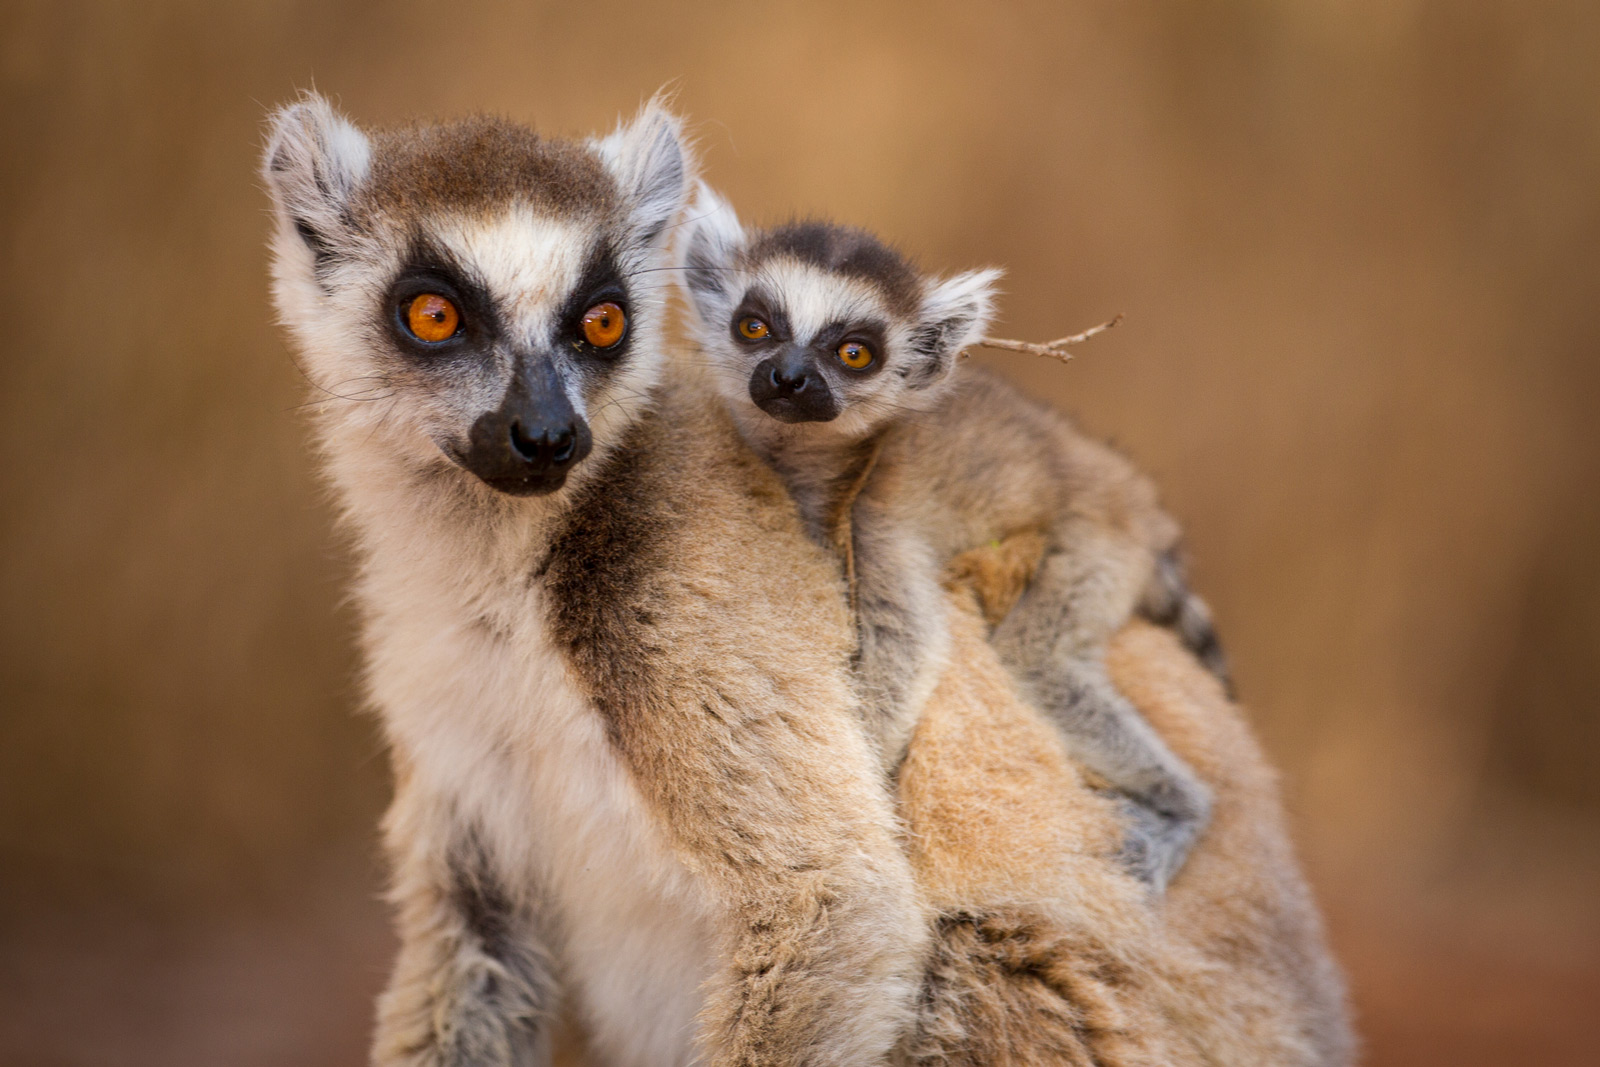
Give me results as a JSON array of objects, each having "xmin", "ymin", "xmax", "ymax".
[{"xmin": 262, "ymin": 96, "xmax": 926, "ymax": 1067}]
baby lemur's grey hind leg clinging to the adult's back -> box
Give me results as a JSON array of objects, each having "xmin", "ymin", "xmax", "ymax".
[{"xmin": 994, "ymin": 518, "xmax": 1211, "ymax": 889}]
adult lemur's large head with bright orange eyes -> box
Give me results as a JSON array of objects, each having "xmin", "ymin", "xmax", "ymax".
[{"xmin": 262, "ymin": 96, "xmax": 690, "ymax": 496}]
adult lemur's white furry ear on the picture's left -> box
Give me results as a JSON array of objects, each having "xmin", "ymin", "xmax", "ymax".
[{"xmin": 261, "ymin": 93, "xmax": 373, "ymax": 267}]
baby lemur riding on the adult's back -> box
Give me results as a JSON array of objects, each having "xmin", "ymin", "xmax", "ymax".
[{"xmin": 682, "ymin": 186, "xmax": 1222, "ymax": 891}]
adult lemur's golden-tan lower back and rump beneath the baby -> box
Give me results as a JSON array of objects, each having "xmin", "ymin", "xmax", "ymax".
[{"xmin": 899, "ymin": 545, "xmax": 1352, "ymax": 1067}]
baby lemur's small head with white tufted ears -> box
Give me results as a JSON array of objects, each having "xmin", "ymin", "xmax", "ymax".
[{"xmin": 682, "ymin": 186, "xmax": 1000, "ymax": 440}]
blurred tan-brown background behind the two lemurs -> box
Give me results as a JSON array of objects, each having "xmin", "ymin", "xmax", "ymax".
[{"xmin": 0, "ymin": 0, "xmax": 1600, "ymax": 1067}]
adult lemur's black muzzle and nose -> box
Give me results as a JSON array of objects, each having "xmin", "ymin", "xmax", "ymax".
[{"xmin": 461, "ymin": 355, "xmax": 594, "ymax": 496}]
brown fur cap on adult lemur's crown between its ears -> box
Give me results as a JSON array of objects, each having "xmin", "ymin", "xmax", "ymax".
[{"xmin": 360, "ymin": 115, "xmax": 618, "ymax": 214}]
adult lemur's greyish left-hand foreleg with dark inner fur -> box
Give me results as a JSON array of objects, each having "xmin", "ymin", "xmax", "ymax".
[{"xmin": 373, "ymin": 776, "xmax": 558, "ymax": 1067}]
